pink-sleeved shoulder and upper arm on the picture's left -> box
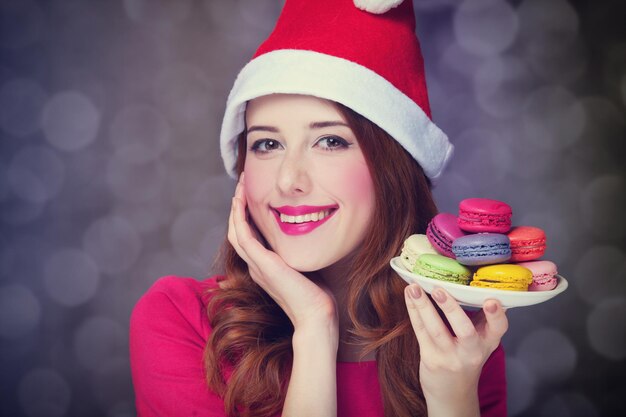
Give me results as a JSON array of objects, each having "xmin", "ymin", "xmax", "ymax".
[{"xmin": 130, "ymin": 276, "xmax": 229, "ymax": 417}]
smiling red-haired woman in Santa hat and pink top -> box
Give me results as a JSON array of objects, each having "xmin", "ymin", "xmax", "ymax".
[{"xmin": 131, "ymin": 0, "xmax": 507, "ymax": 417}]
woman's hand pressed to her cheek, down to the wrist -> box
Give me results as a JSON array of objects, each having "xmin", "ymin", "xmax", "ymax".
[{"xmin": 228, "ymin": 174, "xmax": 338, "ymax": 331}]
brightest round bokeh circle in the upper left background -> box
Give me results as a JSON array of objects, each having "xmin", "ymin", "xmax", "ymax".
[{"xmin": 41, "ymin": 91, "xmax": 101, "ymax": 151}]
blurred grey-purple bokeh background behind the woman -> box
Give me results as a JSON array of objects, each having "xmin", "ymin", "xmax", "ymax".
[{"xmin": 0, "ymin": 0, "xmax": 626, "ymax": 417}]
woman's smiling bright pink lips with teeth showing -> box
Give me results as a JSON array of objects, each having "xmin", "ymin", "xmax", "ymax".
[{"xmin": 272, "ymin": 205, "xmax": 339, "ymax": 236}]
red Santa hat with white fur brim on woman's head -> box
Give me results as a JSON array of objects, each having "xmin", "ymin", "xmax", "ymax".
[{"xmin": 220, "ymin": 0, "xmax": 454, "ymax": 181}]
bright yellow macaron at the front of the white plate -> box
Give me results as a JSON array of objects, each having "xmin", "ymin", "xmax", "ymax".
[{"xmin": 470, "ymin": 264, "xmax": 533, "ymax": 291}]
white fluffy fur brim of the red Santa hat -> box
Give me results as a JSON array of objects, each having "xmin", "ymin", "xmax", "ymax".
[{"xmin": 220, "ymin": 49, "xmax": 454, "ymax": 182}]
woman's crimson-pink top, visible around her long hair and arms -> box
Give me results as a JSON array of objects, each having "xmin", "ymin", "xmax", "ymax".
[{"xmin": 130, "ymin": 277, "xmax": 506, "ymax": 417}]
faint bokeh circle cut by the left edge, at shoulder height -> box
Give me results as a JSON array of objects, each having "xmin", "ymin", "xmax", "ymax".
[{"xmin": 0, "ymin": 284, "xmax": 41, "ymax": 340}]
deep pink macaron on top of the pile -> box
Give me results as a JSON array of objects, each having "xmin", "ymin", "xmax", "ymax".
[{"xmin": 458, "ymin": 198, "xmax": 513, "ymax": 233}]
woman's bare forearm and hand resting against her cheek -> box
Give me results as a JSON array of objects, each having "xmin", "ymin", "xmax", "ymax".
[{"xmin": 228, "ymin": 174, "xmax": 339, "ymax": 417}]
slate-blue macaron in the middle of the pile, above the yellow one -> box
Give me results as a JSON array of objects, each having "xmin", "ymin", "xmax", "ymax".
[{"xmin": 452, "ymin": 233, "xmax": 511, "ymax": 265}]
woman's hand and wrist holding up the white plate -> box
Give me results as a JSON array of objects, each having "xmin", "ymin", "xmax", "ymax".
[{"xmin": 404, "ymin": 284, "xmax": 508, "ymax": 416}]
